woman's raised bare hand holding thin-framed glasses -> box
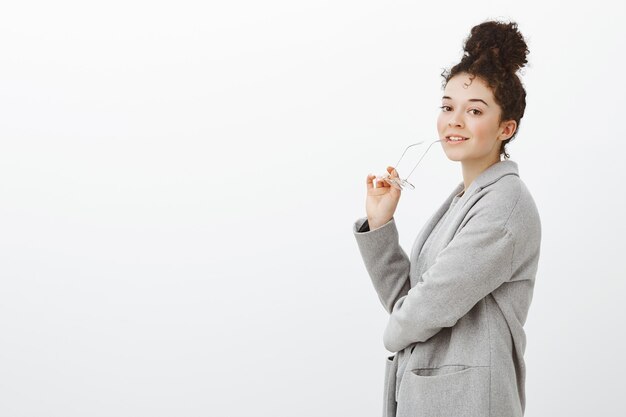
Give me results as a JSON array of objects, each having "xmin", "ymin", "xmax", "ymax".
[{"xmin": 365, "ymin": 167, "xmax": 401, "ymax": 230}]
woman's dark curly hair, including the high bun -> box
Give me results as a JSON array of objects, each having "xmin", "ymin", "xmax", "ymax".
[{"xmin": 441, "ymin": 20, "xmax": 529, "ymax": 159}]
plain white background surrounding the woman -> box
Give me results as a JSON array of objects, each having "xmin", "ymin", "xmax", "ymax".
[{"xmin": 0, "ymin": 0, "xmax": 626, "ymax": 417}]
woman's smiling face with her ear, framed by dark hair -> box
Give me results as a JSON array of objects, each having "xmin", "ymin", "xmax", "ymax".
[{"xmin": 437, "ymin": 73, "xmax": 516, "ymax": 166}]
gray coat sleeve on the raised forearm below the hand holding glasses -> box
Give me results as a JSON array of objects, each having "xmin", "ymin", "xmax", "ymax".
[{"xmin": 353, "ymin": 217, "xmax": 411, "ymax": 313}]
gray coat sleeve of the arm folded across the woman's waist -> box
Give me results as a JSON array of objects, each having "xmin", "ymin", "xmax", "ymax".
[{"xmin": 383, "ymin": 212, "xmax": 515, "ymax": 352}]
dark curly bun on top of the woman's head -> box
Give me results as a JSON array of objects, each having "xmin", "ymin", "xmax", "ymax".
[{"xmin": 463, "ymin": 20, "xmax": 529, "ymax": 74}]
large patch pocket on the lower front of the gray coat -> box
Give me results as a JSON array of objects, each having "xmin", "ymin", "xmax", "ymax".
[{"xmin": 397, "ymin": 365, "xmax": 490, "ymax": 417}]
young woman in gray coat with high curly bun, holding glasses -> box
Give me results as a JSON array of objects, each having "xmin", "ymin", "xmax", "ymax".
[{"xmin": 353, "ymin": 21, "xmax": 541, "ymax": 417}]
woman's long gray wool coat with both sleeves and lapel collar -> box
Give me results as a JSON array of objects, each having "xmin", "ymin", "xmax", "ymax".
[{"xmin": 353, "ymin": 160, "xmax": 541, "ymax": 417}]
